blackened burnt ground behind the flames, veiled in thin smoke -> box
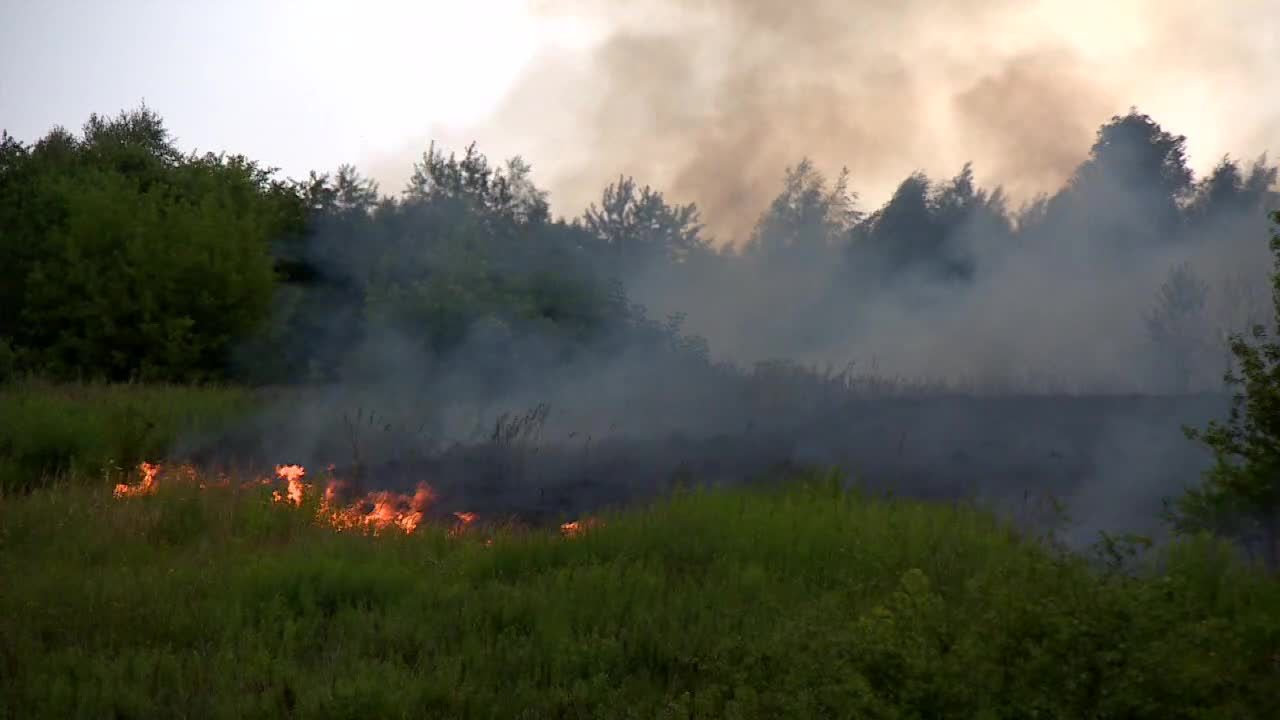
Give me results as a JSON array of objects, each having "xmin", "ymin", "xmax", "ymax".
[{"xmin": 186, "ymin": 395, "xmax": 1229, "ymax": 542}]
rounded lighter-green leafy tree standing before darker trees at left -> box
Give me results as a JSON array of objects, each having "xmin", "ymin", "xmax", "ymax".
[{"xmin": 22, "ymin": 165, "xmax": 281, "ymax": 380}]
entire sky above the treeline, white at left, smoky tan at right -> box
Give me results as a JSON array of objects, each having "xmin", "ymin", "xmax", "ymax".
[{"xmin": 0, "ymin": 0, "xmax": 1280, "ymax": 233}]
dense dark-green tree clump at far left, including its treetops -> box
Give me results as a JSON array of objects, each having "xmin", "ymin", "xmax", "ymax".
[{"xmin": 0, "ymin": 108, "xmax": 302, "ymax": 380}]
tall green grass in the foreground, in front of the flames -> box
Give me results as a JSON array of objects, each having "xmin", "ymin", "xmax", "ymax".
[{"xmin": 0, "ymin": 468, "xmax": 1280, "ymax": 719}]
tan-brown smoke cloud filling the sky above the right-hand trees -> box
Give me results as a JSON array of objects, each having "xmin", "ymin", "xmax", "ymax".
[{"xmin": 372, "ymin": 0, "xmax": 1280, "ymax": 242}]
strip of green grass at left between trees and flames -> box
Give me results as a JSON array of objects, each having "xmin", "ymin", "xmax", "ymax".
[{"xmin": 0, "ymin": 382, "xmax": 253, "ymax": 493}]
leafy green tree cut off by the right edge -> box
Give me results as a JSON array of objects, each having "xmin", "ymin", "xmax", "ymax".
[{"xmin": 1170, "ymin": 213, "xmax": 1280, "ymax": 570}]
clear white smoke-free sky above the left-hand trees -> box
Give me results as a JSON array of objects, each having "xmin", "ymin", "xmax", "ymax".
[{"xmin": 0, "ymin": 0, "xmax": 596, "ymax": 177}]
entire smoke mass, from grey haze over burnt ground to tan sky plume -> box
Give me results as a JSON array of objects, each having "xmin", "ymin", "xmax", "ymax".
[{"xmin": 195, "ymin": 0, "xmax": 1280, "ymax": 548}]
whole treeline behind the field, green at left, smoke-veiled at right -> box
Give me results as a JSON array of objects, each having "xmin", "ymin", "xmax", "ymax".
[{"xmin": 0, "ymin": 108, "xmax": 1276, "ymax": 383}]
